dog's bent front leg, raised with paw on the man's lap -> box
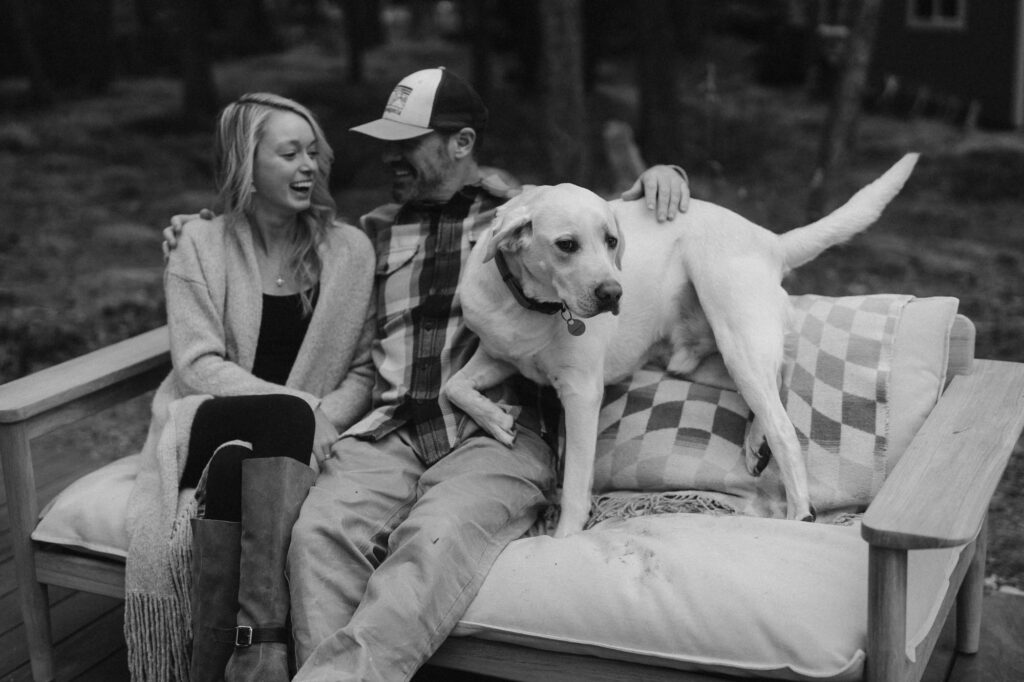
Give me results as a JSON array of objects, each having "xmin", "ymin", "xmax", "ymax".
[{"xmin": 443, "ymin": 348, "xmax": 517, "ymax": 447}]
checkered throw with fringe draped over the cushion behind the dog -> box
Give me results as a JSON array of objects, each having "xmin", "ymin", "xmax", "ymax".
[{"xmin": 594, "ymin": 288, "xmax": 911, "ymax": 517}]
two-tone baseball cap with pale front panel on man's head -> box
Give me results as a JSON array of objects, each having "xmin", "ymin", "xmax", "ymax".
[{"xmin": 349, "ymin": 67, "xmax": 487, "ymax": 140}]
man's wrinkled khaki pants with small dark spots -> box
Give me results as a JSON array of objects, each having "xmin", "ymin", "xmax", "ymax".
[{"xmin": 289, "ymin": 426, "xmax": 553, "ymax": 682}]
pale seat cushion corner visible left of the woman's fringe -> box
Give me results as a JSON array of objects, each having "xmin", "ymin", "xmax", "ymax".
[{"xmin": 32, "ymin": 455, "xmax": 194, "ymax": 559}]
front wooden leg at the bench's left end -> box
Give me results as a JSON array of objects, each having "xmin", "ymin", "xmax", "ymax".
[{"xmin": 0, "ymin": 424, "xmax": 56, "ymax": 682}]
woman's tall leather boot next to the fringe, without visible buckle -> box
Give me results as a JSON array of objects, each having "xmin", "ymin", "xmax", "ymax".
[{"xmin": 189, "ymin": 518, "xmax": 242, "ymax": 682}]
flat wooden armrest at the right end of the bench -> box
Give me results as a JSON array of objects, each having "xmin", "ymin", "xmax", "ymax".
[{"xmin": 861, "ymin": 360, "xmax": 1024, "ymax": 550}]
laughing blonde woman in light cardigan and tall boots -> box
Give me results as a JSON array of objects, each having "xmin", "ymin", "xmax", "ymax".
[{"xmin": 125, "ymin": 93, "xmax": 375, "ymax": 681}]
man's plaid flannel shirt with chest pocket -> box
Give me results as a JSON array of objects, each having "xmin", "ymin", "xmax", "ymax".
[{"xmin": 345, "ymin": 174, "xmax": 540, "ymax": 465}]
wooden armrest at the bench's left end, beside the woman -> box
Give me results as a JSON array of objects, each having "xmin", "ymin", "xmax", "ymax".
[{"xmin": 0, "ymin": 327, "xmax": 170, "ymax": 437}]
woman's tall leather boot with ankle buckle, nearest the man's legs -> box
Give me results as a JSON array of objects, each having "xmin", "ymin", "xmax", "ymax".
[{"xmin": 224, "ymin": 457, "xmax": 315, "ymax": 682}]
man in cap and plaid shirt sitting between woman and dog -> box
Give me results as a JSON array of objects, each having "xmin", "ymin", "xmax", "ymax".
[{"xmin": 165, "ymin": 68, "xmax": 689, "ymax": 682}]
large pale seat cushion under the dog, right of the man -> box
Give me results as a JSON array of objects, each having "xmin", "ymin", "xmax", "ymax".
[{"xmin": 456, "ymin": 514, "xmax": 959, "ymax": 680}]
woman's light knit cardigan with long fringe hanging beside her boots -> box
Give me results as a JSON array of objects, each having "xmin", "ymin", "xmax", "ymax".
[{"xmin": 125, "ymin": 216, "xmax": 375, "ymax": 680}]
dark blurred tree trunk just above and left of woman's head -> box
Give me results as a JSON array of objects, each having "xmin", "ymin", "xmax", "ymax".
[{"xmin": 178, "ymin": 0, "xmax": 217, "ymax": 127}]
